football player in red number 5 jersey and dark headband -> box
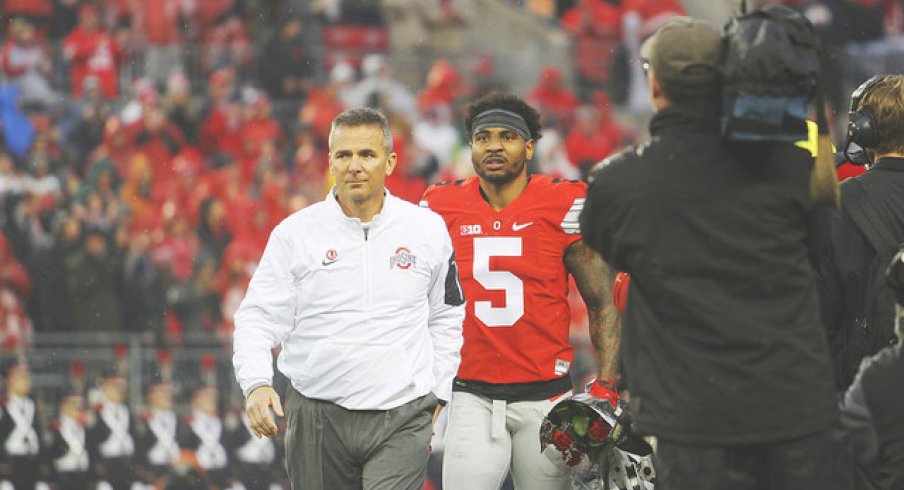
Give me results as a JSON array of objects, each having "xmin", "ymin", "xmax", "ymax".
[{"xmin": 421, "ymin": 93, "xmax": 619, "ymax": 490}]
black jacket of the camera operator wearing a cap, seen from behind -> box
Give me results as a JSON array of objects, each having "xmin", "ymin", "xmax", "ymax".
[{"xmin": 581, "ymin": 107, "xmax": 837, "ymax": 445}]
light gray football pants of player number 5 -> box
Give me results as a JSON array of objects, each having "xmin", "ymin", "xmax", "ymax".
[{"xmin": 443, "ymin": 391, "xmax": 571, "ymax": 490}]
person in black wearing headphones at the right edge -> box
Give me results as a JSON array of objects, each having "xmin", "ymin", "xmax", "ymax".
[{"xmin": 814, "ymin": 75, "xmax": 904, "ymax": 390}]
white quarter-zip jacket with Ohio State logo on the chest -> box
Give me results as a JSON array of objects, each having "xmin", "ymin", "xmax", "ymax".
[{"xmin": 233, "ymin": 192, "xmax": 464, "ymax": 410}]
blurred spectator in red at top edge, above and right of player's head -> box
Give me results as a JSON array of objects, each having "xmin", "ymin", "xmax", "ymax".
[{"xmin": 560, "ymin": 0, "xmax": 622, "ymax": 96}]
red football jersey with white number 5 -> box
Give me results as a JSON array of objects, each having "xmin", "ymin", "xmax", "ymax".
[{"xmin": 421, "ymin": 175, "xmax": 586, "ymax": 384}]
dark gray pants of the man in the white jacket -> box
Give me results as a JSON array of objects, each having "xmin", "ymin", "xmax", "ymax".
[{"xmin": 286, "ymin": 385, "xmax": 437, "ymax": 490}]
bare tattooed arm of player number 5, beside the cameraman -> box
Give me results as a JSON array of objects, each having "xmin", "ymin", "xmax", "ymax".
[{"xmin": 565, "ymin": 240, "xmax": 621, "ymax": 379}]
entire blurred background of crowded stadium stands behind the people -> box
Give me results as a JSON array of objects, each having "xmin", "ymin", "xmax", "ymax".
[{"xmin": 0, "ymin": 0, "xmax": 904, "ymax": 486}]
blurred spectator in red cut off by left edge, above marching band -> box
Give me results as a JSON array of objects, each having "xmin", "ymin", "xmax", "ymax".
[{"xmin": 0, "ymin": 231, "xmax": 32, "ymax": 350}]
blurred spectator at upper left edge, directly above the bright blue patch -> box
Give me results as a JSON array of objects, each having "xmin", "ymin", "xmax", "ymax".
[{"xmin": 0, "ymin": 18, "xmax": 53, "ymax": 107}]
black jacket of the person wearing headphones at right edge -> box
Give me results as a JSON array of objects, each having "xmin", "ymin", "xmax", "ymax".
[{"xmin": 814, "ymin": 158, "xmax": 904, "ymax": 390}]
